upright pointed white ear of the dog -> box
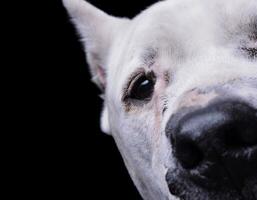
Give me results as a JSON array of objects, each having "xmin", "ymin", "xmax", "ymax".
[{"xmin": 63, "ymin": 0, "xmax": 129, "ymax": 92}]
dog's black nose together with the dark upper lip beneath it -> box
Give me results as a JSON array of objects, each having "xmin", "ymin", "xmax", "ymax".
[{"xmin": 166, "ymin": 100, "xmax": 257, "ymax": 192}]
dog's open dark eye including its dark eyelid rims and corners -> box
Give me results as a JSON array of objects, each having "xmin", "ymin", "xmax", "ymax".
[{"xmin": 124, "ymin": 72, "xmax": 156, "ymax": 101}]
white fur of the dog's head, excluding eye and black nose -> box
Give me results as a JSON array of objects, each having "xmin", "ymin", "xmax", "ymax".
[{"xmin": 63, "ymin": 0, "xmax": 257, "ymax": 200}]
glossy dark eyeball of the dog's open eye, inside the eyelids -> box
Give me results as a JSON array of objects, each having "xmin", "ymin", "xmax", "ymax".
[{"xmin": 128, "ymin": 75, "xmax": 155, "ymax": 100}]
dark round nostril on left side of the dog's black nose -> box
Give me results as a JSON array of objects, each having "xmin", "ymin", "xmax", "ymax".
[{"xmin": 175, "ymin": 137, "xmax": 204, "ymax": 169}]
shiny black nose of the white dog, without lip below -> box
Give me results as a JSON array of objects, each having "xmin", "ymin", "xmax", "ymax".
[{"xmin": 166, "ymin": 101, "xmax": 257, "ymax": 171}]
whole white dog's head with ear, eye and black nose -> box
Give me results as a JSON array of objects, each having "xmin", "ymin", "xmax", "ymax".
[{"xmin": 64, "ymin": 0, "xmax": 257, "ymax": 200}]
